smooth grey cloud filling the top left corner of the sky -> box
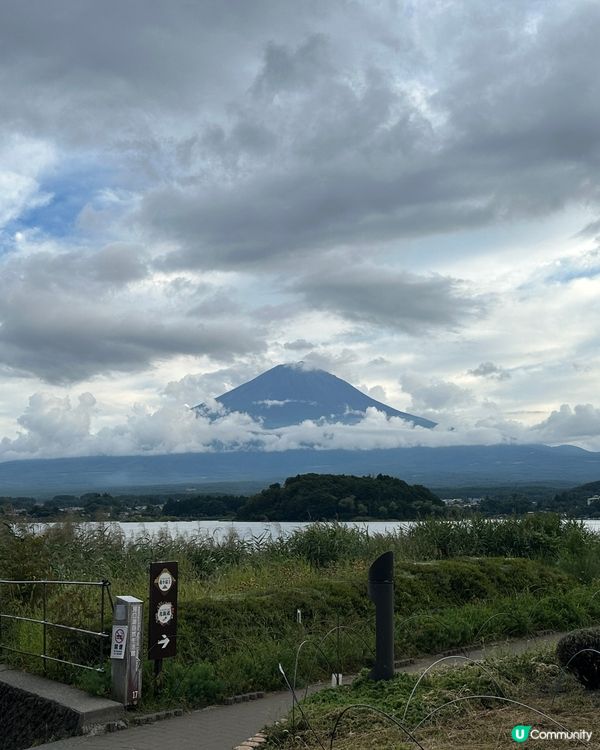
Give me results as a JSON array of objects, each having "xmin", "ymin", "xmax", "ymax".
[{"xmin": 0, "ymin": 0, "xmax": 316, "ymax": 147}]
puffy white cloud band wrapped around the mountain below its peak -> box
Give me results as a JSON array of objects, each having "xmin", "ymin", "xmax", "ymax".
[{"xmin": 0, "ymin": 393, "xmax": 600, "ymax": 461}]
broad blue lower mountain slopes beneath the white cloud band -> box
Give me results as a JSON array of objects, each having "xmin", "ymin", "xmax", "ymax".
[{"xmin": 0, "ymin": 445, "xmax": 600, "ymax": 497}]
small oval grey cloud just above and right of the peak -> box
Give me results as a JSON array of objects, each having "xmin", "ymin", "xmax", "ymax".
[{"xmin": 294, "ymin": 266, "xmax": 482, "ymax": 334}]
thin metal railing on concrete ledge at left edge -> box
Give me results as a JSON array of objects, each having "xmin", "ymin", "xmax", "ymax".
[{"xmin": 0, "ymin": 579, "xmax": 113, "ymax": 672}]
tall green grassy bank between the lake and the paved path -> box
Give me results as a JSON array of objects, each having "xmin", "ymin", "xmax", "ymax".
[{"xmin": 0, "ymin": 515, "xmax": 600, "ymax": 705}]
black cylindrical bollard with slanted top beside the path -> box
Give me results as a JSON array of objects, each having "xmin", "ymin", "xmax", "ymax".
[{"xmin": 368, "ymin": 552, "xmax": 394, "ymax": 680}]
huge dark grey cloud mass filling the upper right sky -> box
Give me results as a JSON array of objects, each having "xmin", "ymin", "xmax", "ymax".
[{"xmin": 139, "ymin": 2, "xmax": 600, "ymax": 268}]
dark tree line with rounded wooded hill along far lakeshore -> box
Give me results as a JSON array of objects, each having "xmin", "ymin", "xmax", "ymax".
[{"xmin": 0, "ymin": 473, "xmax": 600, "ymax": 521}]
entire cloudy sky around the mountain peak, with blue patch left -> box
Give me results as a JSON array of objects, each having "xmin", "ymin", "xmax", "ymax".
[{"xmin": 0, "ymin": 0, "xmax": 600, "ymax": 460}]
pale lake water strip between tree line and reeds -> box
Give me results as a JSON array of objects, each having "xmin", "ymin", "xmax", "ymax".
[{"xmin": 34, "ymin": 519, "xmax": 600, "ymax": 541}]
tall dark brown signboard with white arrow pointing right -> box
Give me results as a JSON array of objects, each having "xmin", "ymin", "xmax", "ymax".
[{"xmin": 148, "ymin": 562, "xmax": 179, "ymax": 661}]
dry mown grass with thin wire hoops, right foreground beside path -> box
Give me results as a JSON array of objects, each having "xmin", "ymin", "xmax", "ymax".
[{"xmin": 267, "ymin": 650, "xmax": 600, "ymax": 750}]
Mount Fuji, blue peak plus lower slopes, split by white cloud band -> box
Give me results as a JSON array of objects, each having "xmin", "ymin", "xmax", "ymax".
[{"xmin": 0, "ymin": 363, "xmax": 600, "ymax": 496}]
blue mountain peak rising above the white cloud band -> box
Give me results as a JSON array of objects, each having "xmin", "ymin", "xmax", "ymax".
[{"xmin": 194, "ymin": 362, "xmax": 436, "ymax": 429}]
